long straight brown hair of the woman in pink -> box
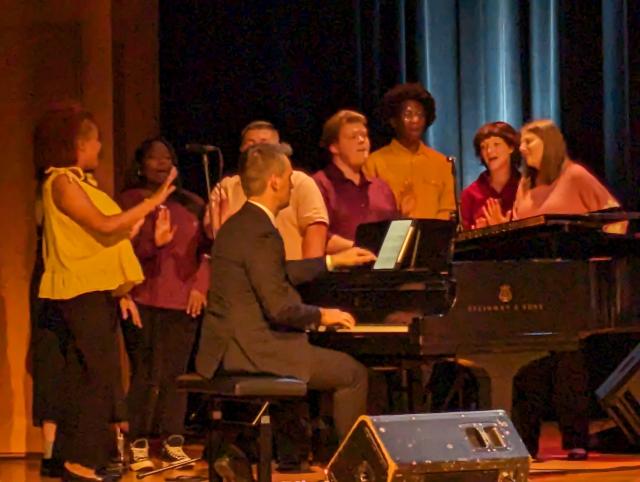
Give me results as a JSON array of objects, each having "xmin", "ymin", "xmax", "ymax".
[{"xmin": 521, "ymin": 119, "xmax": 568, "ymax": 187}]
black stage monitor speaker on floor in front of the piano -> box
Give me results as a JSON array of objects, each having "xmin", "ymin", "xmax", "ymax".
[{"xmin": 326, "ymin": 410, "xmax": 531, "ymax": 482}]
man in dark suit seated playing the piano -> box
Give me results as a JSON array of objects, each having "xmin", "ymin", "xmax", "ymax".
[{"xmin": 196, "ymin": 140, "xmax": 375, "ymax": 437}]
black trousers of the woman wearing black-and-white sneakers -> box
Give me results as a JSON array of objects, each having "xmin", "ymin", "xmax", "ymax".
[{"xmin": 122, "ymin": 305, "xmax": 198, "ymax": 439}]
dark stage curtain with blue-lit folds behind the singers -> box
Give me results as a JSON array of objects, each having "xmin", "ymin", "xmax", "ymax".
[{"xmin": 160, "ymin": 0, "xmax": 640, "ymax": 207}]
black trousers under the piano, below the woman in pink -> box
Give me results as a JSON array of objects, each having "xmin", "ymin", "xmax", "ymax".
[{"xmin": 512, "ymin": 351, "xmax": 589, "ymax": 457}]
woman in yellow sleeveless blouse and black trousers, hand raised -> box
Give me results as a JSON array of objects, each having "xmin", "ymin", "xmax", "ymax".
[{"xmin": 34, "ymin": 105, "xmax": 176, "ymax": 481}]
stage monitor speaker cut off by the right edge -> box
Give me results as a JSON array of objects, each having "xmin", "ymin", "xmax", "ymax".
[{"xmin": 596, "ymin": 345, "xmax": 640, "ymax": 444}]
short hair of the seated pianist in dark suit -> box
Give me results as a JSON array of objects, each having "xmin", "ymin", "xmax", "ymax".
[{"xmin": 239, "ymin": 143, "xmax": 293, "ymax": 197}]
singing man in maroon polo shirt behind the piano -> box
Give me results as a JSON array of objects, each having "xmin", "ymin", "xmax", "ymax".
[{"xmin": 313, "ymin": 110, "xmax": 398, "ymax": 253}]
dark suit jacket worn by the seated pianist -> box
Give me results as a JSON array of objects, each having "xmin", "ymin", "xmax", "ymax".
[{"xmin": 196, "ymin": 202, "xmax": 326, "ymax": 381}]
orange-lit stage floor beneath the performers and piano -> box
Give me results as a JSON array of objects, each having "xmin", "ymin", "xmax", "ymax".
[{"xmin": 0, "ymin": 424, "xmax": 640, "ymax": 482}]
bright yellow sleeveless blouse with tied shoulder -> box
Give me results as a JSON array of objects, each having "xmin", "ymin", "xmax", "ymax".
[{"xmin": 39, "ymin": 167, "xmax": 144, "ymax": 300}]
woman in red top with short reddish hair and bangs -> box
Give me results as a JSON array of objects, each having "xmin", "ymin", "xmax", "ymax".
[{"xmin": 461, "ymin": 122, "xmax": 520, "ymax": 229}]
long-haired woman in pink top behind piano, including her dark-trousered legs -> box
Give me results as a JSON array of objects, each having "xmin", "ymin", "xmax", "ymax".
[{"xmin": 490, "ymin": 120, "xmax": 619, "ymax": 459}]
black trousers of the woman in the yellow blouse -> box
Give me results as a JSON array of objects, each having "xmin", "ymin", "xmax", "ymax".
[{"xmin": 50, "ymin": 292, "xmax": 123, "ymax": 468}]
